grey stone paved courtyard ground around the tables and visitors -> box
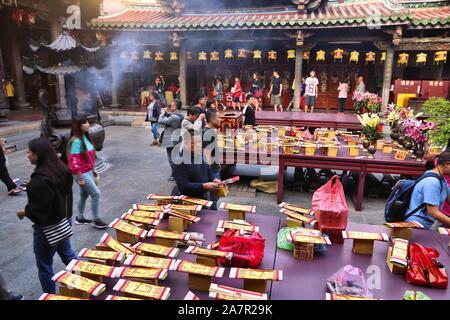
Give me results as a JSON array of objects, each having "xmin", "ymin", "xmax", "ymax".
[{"xmin": 0, "ymin": 126, "xmax": 384, "ymax": 299}]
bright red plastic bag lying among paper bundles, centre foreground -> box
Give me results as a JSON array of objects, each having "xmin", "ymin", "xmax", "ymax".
[{"xmin": 217, "ymin": 229, "xmax": 265, "ymax": 268}]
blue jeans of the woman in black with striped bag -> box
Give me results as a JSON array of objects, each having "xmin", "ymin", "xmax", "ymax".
[{"xmin": 33, "ymin": 219, "xmax": 77, "ymax": 294}]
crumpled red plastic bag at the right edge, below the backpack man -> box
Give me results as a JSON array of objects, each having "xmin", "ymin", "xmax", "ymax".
[{"xmin": 406, "ymin": 243, "xmax": 448, "ymax": 289}]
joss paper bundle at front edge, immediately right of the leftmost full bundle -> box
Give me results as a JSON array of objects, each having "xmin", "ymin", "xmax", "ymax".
[{"xmin": 113, "ymin": 279, "xmax": 170, "ymax": 300}]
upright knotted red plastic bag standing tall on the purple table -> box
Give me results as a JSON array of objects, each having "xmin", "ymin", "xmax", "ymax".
[{"xmin": 311, "ymin": 176, "xmax": 348, "ymax": 230}]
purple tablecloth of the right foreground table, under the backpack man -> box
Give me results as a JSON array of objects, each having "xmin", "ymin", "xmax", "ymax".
[{"xmin": 271, "ymin": 222, "xmax": 450, "ymax": 300}]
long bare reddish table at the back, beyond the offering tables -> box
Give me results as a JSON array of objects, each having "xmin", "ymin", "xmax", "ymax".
[{"xmin": 256, "ymin": 111, "xmax": 362, "ymax": 130}]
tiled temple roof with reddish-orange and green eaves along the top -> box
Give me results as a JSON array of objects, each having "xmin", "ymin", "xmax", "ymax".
[{"xmin": 89, "ymin": 0, "xmax": 450, "ymax": 31}]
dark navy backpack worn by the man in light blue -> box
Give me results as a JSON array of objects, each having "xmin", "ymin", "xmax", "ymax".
[{"xmin": 384, "ymin": 172, "xmax": 442, "ymax": 222}]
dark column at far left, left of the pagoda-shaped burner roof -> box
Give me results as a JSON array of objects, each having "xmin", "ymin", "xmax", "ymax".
[{"xmin": 6, "ymin": 21, "xmax": 30, "ymax": 108}]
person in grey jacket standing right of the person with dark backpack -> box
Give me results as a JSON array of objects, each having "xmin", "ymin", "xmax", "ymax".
[{"xmin": 158, "ymin": 100, "xmax": 184, "ymax": 181}]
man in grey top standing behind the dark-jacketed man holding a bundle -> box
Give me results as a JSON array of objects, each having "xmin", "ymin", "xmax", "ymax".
[{"xmin": 202, "ymin": 108, "xmax": 221, "ymax": 210}]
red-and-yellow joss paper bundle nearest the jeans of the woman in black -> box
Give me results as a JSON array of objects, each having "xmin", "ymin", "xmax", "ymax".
[{"xmin": 52, "ymin": 271, "xmax": 106, "ymax": 298}]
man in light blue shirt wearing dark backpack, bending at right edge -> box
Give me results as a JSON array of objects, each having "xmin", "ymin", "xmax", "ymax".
[{"xmin": 385, "ymin": 151, "xmax": 450, "ymax": 229}]
